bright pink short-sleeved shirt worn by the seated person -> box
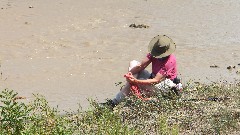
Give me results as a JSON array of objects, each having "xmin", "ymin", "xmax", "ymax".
[{"xmin": 147, "ymin": 53, "xmax": 177, "ymax": 80}]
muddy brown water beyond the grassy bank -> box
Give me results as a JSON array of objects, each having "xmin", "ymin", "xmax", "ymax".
[{"xmin": 0, "ymin": 0, "xmax": 240, "ymax": 110}]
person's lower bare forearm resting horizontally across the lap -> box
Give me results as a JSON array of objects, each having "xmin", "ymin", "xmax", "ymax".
[{"xmin": 129, "ymin": 73, "xmax": 165, "ymax": 85}]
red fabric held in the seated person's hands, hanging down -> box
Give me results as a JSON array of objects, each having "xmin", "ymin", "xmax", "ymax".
[{"xmin": 124, "ymin": 74, "xmax": 150, "ymax": 101}]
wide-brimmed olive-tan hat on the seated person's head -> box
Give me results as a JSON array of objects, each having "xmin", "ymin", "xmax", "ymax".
[{"xmin": 148, "ymin": 35, "xmax": 176, "ymax": 58}]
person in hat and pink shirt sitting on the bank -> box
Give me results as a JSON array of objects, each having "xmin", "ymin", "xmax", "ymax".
[{"xmin": 102, "ymin": 35, "xmax": 182, "ymax": 108}]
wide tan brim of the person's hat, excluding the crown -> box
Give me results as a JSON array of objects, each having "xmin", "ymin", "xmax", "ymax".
[{"xmin": 148, "ymin": 35, "xmax": 176, "ymax": 58}]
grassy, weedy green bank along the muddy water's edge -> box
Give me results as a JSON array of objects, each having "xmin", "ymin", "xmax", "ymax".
[{"xmin": 0, "ymin": 82, "xmax": 240, "ymax": 135}]
